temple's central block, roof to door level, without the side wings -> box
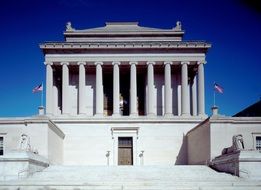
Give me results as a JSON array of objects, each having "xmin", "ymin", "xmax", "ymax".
[{"xmin": 35, "ymin": 22, "xmax": 211, "ymax": 165}]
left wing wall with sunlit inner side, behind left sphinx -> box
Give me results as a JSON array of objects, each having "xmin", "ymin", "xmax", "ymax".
[{"xmin": 0, "ymin": 117, "xmax": 64, "ymax": 164}]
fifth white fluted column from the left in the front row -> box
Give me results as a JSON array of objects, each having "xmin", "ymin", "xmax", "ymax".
[{"xmin": 112, "ymin": 62, "xmax": 120, "ymax": 116}]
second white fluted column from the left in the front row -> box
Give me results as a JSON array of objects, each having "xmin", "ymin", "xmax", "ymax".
[{"xmin": 61, "ymin": 62, "xmax": 69, "ymax": 114}]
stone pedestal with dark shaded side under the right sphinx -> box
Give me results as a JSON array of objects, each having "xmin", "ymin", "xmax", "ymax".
[{"xmin": 210, "ymin": 150, "xmax": 261, "ymax": 180}]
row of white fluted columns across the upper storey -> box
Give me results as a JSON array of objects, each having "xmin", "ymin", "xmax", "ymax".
[{"xmin": 45, "ymin": 61, "xmax": 205, "ymax": 116}]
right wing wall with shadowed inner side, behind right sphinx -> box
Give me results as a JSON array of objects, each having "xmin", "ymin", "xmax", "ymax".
[{"xmin": 187, "ymin": 116, "xmax": 261, "ymax": 164}]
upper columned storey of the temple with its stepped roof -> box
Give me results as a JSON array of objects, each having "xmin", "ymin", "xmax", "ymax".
[{"xmin": 40, "ymin": 23, "xmax": 211, "ymax": 117}]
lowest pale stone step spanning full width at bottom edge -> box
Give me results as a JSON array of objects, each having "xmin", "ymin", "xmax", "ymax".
[{"xmin": 0, "ymin": 180, "xmax": 261, "ymax": 190}]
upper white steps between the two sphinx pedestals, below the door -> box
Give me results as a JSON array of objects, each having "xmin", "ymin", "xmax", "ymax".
[{"xmin": 32, "ymin": 166, "xmax": 237, "ymax": 180}]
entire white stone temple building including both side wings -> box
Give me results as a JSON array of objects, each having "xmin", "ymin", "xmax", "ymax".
[{"xmin": 0, "ymin": 22, "xmax": 261, "ymax": 186}]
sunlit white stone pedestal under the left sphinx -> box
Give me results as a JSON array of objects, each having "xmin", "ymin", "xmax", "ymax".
[{"xmin": 0, "ymin": 150, "xmax": 49, "ymax": 181}]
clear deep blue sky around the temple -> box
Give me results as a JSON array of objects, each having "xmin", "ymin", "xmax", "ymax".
[{"xmin": 0, "ymin": 0, "xmax": 261, "ymax": 117}]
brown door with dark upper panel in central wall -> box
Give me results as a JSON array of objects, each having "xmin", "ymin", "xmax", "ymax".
[{"xmin": 118, "ymin": 137, "xmax": 133, "ymax": 165}]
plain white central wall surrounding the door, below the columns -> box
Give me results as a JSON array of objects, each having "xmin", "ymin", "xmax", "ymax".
[{"xmin": 53, "ymin": 117, "xmax": 201, "ymax": 165}]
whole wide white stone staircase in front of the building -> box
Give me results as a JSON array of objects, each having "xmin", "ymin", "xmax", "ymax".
[{"xmin": 0, "ymin": 165, "xmax": 261, "ymax": 190}]
